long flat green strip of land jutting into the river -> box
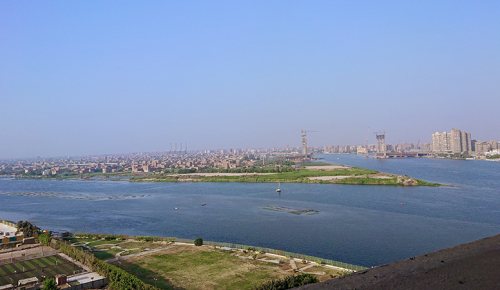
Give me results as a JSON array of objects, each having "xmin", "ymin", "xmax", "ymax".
[{"xmin": 5, "ymin": 161, "xmax": 441, "ymax": 186}]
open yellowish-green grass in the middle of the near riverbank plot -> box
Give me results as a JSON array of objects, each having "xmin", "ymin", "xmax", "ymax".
[{"xmin": 112, "ymin": 246, "xmax": 338, "ymax": 289}]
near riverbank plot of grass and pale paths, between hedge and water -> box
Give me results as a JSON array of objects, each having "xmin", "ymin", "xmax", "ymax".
[{"xmin": 70, "ymin": 234, "xmax": 365, "ymax": 289}]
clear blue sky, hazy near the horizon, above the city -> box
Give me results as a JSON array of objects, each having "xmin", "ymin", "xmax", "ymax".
[{"xmin": 0, "ymin": 0, "xmax": 500, "ymax": 158}]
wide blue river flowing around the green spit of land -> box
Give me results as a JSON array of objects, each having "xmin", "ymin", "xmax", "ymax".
[{"xmin": 0, "ymin": 155, "xmax": 500, "ymax": 266}]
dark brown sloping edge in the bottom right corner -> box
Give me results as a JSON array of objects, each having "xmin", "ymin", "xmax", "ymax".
[{"xmin": 297, "ymin": 235, "xmax": 500, "ymax": 290}]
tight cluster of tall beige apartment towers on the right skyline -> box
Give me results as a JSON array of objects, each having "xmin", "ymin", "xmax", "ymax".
[{"xmin": 432, "ymin": 129, "xmax": 472, "ymax": 153}]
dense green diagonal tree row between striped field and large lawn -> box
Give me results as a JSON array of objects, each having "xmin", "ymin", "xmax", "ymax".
[{"xmin": 52, "ymin": 240, "xmax": 158, "ymax": 290}]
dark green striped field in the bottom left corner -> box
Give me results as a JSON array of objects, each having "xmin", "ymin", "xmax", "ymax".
[{"xmin": 0, "ymin": 255, "xmax": 82, "ymax": 286}]
